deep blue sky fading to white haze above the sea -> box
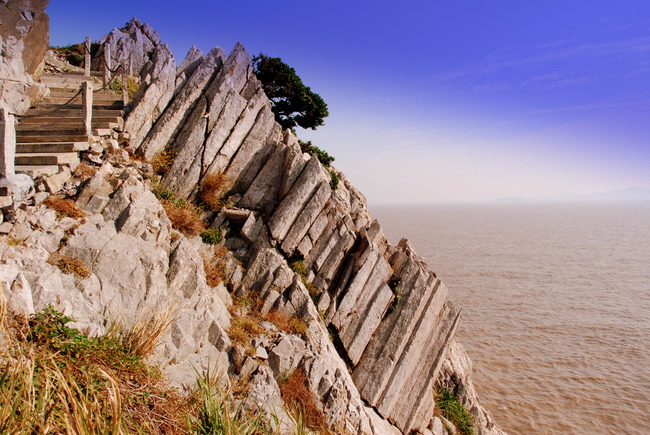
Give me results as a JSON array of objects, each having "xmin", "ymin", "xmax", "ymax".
[{"xmin": 47, "ymin": 0, "xmax": 650, "ymax": 204}]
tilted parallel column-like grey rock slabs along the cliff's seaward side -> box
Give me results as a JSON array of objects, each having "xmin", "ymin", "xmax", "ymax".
[{"xmin": 119, "ymin": 33, "xmax": 502, "ymax": 433}]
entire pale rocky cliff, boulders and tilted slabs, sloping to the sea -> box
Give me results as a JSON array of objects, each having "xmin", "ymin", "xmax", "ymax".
[{"xmin": 0, "ymin": 12, "xmax": 502, "ymax": 434}]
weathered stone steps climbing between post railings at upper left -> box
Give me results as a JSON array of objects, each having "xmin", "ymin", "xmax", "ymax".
[{"xmin": 15, "ymin": 72, "xmax": 124, "ymax": 178}]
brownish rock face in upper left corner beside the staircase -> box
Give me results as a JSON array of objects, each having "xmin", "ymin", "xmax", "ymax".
[{"xmin": 0, "ymin": 0, "xmax": 50, "ymax": 114}]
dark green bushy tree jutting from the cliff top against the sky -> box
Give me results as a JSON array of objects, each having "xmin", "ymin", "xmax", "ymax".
[{"xmin": 253, "ymin": 53, "xmax": 329, "ymax": 130}]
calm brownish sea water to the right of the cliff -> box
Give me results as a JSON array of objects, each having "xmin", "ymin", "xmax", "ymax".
[{"xmin": 371, "ymin": 203, "xmax": 650, "ymax": 435}]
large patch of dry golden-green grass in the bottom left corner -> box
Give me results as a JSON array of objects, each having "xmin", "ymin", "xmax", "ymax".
[{"xmin": 0, "ymin": 306, "xmax": 193, "ymax": 435}]
